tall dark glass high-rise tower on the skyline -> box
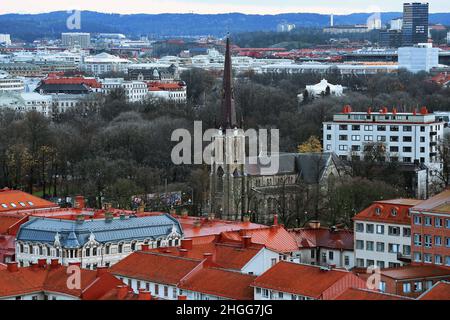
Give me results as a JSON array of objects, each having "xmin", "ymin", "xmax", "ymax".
[{"xmin": 402, "ymin": 2, "xmax": 429, "ymax": 46}]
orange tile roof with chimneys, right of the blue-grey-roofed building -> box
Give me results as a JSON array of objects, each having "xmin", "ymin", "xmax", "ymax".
[{"xmin": 150, "ymin": 243, "xmax": 263, "ymax": 270}]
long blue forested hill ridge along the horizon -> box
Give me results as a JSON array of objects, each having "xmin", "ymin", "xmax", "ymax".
[{"xmin": 0, "ymin": 11, "xmax": 450, "ymax": 41}]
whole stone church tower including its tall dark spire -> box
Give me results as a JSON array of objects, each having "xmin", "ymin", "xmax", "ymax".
[{"xmin": 209, "ymin": 37, "xmax": 246, "ymax": 220}]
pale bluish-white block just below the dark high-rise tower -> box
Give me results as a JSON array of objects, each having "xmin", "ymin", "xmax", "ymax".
[{"xmin": 398, "ymin": 43, "xmax": 439, "ymax": 73}]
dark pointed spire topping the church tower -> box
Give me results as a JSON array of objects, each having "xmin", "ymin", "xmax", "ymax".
[{"xmin": 220, "ymin": 36, "xmax": 237, "ymax": 130}]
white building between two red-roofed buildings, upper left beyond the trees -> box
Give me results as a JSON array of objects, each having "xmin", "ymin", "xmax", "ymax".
[{"xmin": 101, "ymin": 78, "xmax": 148, "ymax": 102}]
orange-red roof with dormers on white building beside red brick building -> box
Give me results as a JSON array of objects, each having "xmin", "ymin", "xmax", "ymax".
[{"xmin": 353, "ymin": 199, "xmax": 422, "ymax": 225}]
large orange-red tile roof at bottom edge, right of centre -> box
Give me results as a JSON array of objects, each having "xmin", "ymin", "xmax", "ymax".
[{"xmin": 253, "ymin": 261, "xmax": 365, "ymax": 299}]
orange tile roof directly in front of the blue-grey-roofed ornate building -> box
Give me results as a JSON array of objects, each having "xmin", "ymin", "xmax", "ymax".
[{"xmin": 111, "ymin": 251, "xmax": 201, "ymax": 285}]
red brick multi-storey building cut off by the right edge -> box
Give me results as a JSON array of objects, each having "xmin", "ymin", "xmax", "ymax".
[{"xmin": 410, "ymin": 190, "xmax": 450, "ymax": 267}]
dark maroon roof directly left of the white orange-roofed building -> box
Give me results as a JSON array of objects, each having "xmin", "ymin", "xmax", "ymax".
[{"xmin": 289, "ymin": 228, "xmax": 353, "ymax": 250}]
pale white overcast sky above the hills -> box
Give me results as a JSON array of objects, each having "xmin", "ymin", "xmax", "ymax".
[{"xmin": 0, "ymin": 0, "xmax": 450, "ymax": 14}]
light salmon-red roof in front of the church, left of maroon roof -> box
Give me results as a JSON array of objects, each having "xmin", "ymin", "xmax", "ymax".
[{"xmin": 219, "ymin": 225, "xmax": 298, "ymax": 253}]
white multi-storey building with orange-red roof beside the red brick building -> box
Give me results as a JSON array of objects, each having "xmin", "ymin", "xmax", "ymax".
[{"xmin": 353, "ymin": 199, "xmax": 421, "ymax": 269}]
